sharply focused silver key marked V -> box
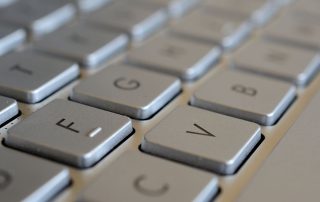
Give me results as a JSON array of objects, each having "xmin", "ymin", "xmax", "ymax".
[{"xmin": 142, "ymin": 107, "xmax": 261, "ymax": 174}]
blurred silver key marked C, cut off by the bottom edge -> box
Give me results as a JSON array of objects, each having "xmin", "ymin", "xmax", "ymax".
[{"xmin": 80, "ymin": 152, "xmax": 218, "ymax": 202}]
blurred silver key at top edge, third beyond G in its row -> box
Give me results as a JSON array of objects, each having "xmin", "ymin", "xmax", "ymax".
[{"xmin": 204, "ymin": 0, "xmax": 278, "ymax": 25}]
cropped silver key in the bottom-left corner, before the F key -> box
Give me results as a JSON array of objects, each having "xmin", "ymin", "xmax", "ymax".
[{"xmin": 0, "ymin": 145, "xmax": 70, "ymax": 202}]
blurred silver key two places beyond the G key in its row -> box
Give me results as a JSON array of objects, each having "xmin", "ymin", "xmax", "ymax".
[{"xmin": 172, "ymin": 8, "xmax": 252, "ymax": 50}]
